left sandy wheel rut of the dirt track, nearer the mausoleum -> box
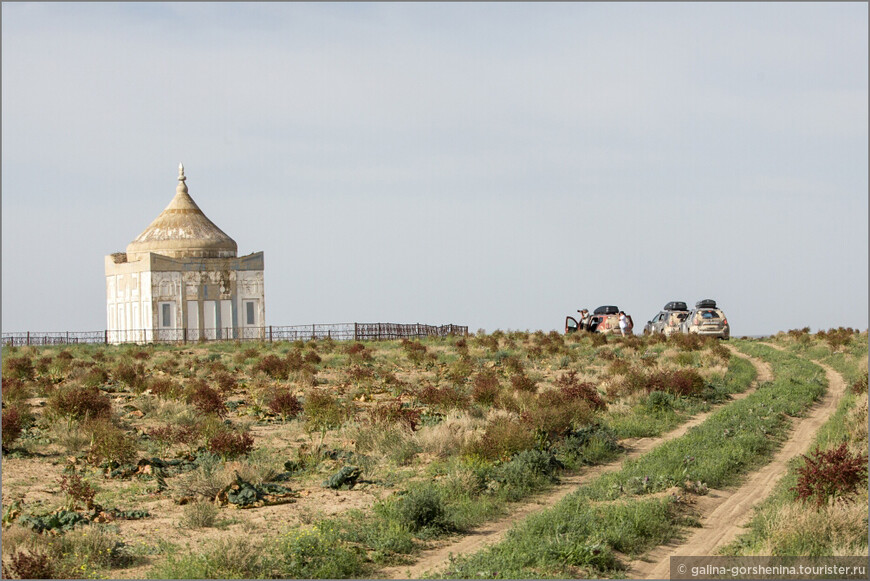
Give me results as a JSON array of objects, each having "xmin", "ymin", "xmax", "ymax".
[{"xmin": 377, "ymin": 345, "xmax": 773, "ymax": 579}]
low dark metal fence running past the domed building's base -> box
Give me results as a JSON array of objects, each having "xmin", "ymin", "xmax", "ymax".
[{"xmin": 2, "ymin": 323, "xmax": 468, "ymax": 346}]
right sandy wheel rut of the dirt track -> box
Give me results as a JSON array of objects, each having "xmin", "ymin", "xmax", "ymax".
[{"xmin": 626, "ymin": 343, "xmax": 846, "ymax": 579}]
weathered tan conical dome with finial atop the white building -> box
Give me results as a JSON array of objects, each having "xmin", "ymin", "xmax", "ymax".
[{"xmin": 127, "ymin": 164, "xmax": 238, "ymax": 261}]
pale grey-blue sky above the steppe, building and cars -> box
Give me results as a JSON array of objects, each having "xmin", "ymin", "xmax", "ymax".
[{"xmin": 2, "ymin": 2, "xmax": 868, "ymax": 336}]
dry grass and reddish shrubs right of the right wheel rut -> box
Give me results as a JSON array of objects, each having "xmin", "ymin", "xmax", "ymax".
[{"xmin": 723, "ymin": 329, "xmax": 868, "ymax": 556}]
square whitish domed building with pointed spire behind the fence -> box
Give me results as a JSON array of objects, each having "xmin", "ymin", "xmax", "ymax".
[{"xmin": 106, "ymin": 165, "xmax": 266, "ymax": 343}]
